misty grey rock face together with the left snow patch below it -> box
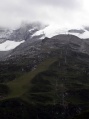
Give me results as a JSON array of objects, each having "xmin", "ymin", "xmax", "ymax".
[{"xmin": 0, "ymin": 23, "xmax": 45, "ymax": 51}]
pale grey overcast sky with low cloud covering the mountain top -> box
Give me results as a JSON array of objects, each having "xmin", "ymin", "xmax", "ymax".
[{"xmin": 0, "ymin": 0, "xmax": 89, "ymax": 27}]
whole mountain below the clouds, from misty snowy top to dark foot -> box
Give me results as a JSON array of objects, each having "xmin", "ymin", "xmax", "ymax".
[{"xmin": 0, "ymin": 24, "xmax": 89, "ymax": 119}]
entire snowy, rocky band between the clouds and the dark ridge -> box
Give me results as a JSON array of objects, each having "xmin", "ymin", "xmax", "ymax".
[{"xmin": 0, "ymin": 22, "xmax": 89, "ymax": 51}]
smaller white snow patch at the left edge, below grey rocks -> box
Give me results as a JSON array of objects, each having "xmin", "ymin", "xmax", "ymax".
[{"xmin": 0, "ymin": 40, "xmax": 25, "ymax": 51}]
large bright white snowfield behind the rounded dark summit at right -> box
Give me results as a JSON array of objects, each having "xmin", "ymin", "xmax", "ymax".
[{"xmin": 32, "ymin": 24, "xmax": 89, "ymax": 39}]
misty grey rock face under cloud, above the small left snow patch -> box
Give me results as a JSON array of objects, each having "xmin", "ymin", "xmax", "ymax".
[{"xmin": 0, "ymin": 23, "xmax": 44, "ymax": 41}]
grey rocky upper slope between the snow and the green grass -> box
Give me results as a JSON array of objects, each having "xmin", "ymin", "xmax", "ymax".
[{"xmin": 0, "ymin": 35, "xmax": 89, "ymax": 82}]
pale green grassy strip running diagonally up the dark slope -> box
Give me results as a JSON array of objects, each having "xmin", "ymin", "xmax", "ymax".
[{"xmin": 3, "ymin": 58, "xmax": 57, "ymax": 99}]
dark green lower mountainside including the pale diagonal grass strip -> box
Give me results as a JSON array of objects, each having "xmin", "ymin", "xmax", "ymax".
[{"xmin": 0, "ymin": 50, "xmax": 89, "ymax": 119}]
